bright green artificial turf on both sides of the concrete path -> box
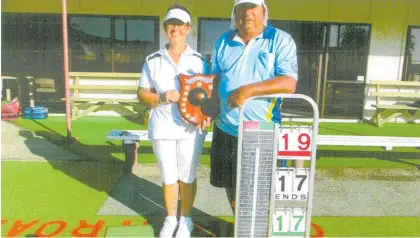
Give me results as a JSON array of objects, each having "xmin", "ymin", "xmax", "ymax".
[{"xmin": 1, "ymin": 105, "xmax": 420, "ymax": 237}]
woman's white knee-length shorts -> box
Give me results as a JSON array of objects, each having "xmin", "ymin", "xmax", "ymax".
[{"xmin": 152, "ymin": 131, "xmax": 206, "ymax": 184}]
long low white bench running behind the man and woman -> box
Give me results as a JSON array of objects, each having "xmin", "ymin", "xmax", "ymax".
[{"xmin": 106, "ymin": 130, "xmax": 420, "ymax": 173}]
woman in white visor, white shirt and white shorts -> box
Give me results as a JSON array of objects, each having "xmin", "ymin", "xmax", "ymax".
[{"xmin": 138, "ymin": 5, "xmax": 208, "ymax": 237}]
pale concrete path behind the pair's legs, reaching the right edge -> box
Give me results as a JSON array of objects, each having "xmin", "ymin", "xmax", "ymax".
[{"xmin": 98, "ymin": 164, "xmax": 420, "ymax": 216}]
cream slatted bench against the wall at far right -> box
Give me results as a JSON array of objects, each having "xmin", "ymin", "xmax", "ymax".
[{"xmin": 370, "ymin": 80, "xmax": 420, "ymax": 127}]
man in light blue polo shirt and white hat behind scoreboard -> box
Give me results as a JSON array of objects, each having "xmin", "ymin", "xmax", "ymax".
[{"xmin": 210, "ymin": 0, "xmax": 298, "ymax": 212}]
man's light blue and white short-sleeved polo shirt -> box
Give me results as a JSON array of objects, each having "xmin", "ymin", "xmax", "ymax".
[{"xmin": 212, "ymin": 25, "xmax": 298, "ymax": 136}]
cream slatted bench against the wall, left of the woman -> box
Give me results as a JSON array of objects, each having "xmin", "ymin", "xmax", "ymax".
[{"xmin": 63, "ymin": 72, "xmax": 144, "ymax": 120}]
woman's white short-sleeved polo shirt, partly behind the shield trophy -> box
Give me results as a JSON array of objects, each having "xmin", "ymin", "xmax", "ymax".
[{"xmin": 139, "ymin": 45, "xmax": 209, "ymax": 139}]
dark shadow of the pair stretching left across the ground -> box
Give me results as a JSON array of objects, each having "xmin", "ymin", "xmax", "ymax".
[{"xmin": 16, "ymin": 121, "xmax": 233, "ymax": 237}]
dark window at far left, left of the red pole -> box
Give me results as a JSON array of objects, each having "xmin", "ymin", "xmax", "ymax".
[{"xmin": 2, "ymin": 13, "xmax": 62, "ymax": 76}]
